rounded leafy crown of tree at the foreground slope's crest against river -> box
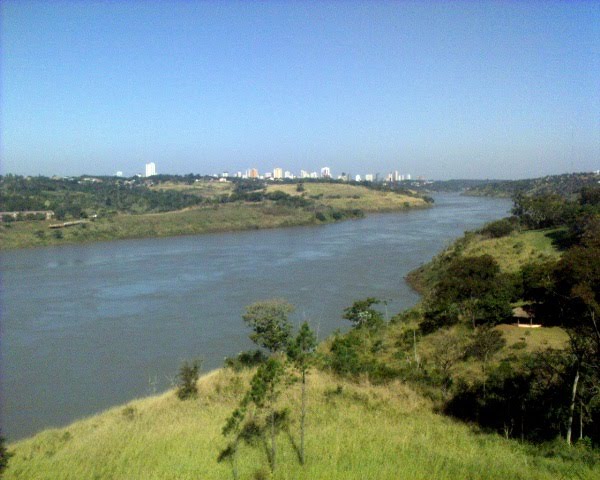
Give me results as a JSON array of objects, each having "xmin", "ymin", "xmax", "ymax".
[{"xmin": 242, "ymin": 299, "xmax": 294, "ymax": 353}]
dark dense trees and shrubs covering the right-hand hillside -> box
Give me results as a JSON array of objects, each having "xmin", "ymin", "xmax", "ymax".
[{"xmin": 388, "ymin": 187, "xmax": 600, "ymax": 444}]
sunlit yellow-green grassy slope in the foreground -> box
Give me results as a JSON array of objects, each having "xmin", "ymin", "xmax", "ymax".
[{"xmin": 6, "ymin": 370, "xmax": 599, "ymax": 480}]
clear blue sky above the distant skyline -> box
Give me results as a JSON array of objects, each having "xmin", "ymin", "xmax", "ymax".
[{"xmin": 0, "ymin": 0, "xmax": 600, "ymax": 179}]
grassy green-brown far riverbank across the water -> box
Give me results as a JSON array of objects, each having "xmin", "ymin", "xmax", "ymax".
[{"xmin": 0, "ymin": 184, "xmax": 431, "ymax": 250}]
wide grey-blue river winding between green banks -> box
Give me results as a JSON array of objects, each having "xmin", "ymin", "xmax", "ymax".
[{"xmin": 0, "ymin": 195, "xmax": 510, "ymax": 441}]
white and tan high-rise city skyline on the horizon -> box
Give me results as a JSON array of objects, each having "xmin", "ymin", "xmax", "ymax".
[{"xmin": 130, "ymin": 162, "xmax": 424, "ymax": 182}]
